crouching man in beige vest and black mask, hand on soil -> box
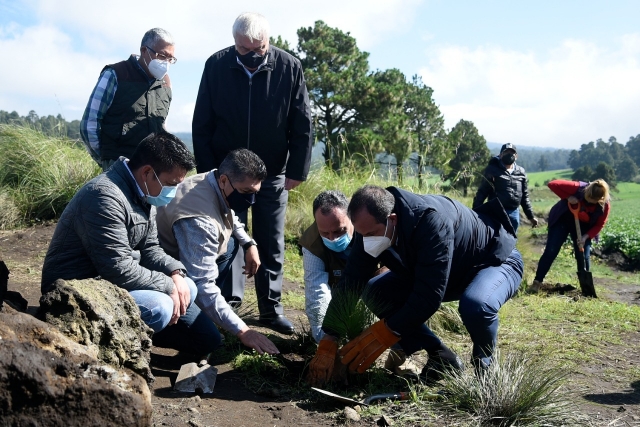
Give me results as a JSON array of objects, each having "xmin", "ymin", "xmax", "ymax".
[{"xmin": 157, "ymin": 149, "xmax": 278, "ymax": 354}]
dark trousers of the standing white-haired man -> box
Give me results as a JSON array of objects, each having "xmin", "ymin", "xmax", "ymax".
[{"xmin": 222, "ymin": 175, "xmax": 289, "ymax": 316}]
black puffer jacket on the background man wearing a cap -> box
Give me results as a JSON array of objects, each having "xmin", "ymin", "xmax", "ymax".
[{"xmin": 473, "ymin": 156, "xmax": 534, "ymax": 220}]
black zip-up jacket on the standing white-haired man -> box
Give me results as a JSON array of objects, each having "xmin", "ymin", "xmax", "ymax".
[{"xmin": 193, "ymin": 46, "xmax": 313, "ymax": 181}]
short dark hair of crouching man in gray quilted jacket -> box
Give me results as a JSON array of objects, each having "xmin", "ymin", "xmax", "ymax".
[{"xmin": 129, "ymin": 132, "xmax": 196, "ymax": 175}]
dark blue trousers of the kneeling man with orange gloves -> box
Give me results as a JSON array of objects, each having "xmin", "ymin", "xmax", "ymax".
[{"xmin": 365, "ymin": 249, "xmax": 524, "ymax": 366}]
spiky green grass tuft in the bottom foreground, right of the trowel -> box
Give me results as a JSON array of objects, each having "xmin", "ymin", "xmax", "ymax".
[{"xmin": 435, "ymin": 353, "xmax": 580, "ymax": 426}]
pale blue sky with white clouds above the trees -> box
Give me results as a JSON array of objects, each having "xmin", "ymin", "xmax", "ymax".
[{"xmin": 0, "ymin": 0, "xmax": 640, "ymax": 148}]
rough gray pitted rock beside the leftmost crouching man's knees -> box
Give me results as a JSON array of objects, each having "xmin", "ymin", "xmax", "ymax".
[{"xmin": 38, "ymin": 279, "xmax": 154, "ymax": 385}]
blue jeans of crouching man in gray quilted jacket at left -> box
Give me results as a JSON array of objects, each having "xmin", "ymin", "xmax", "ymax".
[{"xmin": 129, "ymin": 277, "xmax": 222, "ymax": 355}]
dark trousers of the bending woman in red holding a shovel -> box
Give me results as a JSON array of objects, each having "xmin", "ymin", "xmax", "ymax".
[{"xmin": 535, "ymin": 216, "xmax": 591, "ymax": 282}]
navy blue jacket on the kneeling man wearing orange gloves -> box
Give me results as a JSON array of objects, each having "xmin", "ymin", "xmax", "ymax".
[{"xmin": 323, "ymin": 187, "xmax": 516, "ymax": 335}]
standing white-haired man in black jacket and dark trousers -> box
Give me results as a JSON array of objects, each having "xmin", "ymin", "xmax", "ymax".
[{"xmin": 193, "ymin": 13, "xmax": 312, "ymax": 334}]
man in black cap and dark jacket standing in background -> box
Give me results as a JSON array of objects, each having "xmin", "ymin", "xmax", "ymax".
[{"xmin": 473, "ymin": 143, "xmax": 538, "ymax": 232}]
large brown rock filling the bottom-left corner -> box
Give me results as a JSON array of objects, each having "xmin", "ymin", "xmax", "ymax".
[{"xmin": 0, "ymin": 306, "xmax": 152, "ymax": 427}]
